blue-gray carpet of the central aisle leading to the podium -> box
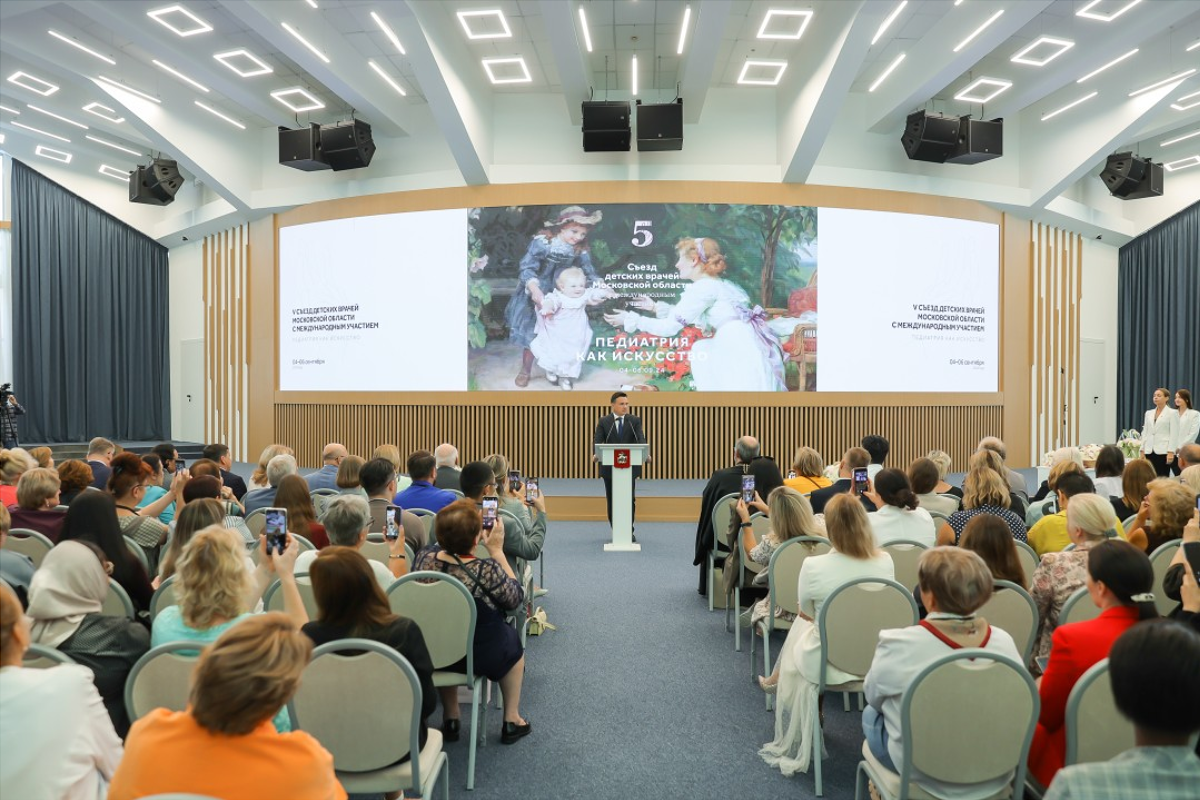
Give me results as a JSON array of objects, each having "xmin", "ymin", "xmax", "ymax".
[{"xmin": 352, "ymin": 523, "xmax": 863, "ymax": 800}]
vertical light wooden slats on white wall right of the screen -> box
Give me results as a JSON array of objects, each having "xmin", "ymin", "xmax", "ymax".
[{"xmin": 1030, "ymin": 224, "xmax": 1084, "ymax": 463}]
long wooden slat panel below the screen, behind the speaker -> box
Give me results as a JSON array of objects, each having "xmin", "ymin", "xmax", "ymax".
[{"xmin": 275, "ymin": 396, "xmax": 1003, "ymax": 479}]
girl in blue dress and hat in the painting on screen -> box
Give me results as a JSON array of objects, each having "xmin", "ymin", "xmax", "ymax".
[{"xmin": 504, "ymin": 205, "xmax": 604, "ymax": 386}]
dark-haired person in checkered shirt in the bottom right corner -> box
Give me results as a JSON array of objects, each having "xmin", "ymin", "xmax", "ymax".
[{"xmin": 1045, "ymin": 621, "xmax": 1200, "ymax": 800}]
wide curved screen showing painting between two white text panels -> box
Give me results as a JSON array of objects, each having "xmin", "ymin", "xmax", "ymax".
[{"xmin": 280, "ymin": 204, "xmax": 1000, "ymax": 392}]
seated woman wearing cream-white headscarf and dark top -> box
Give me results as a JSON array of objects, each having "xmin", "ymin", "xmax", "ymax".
[{"xmin": 26, "ymin": 541, "xmax": 150, "ymax": 734}]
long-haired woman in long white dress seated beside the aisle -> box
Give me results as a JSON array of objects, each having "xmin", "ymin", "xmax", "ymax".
[{"xmin": 758, "ymin": 494, "xmax": 895, "ymax": 776}]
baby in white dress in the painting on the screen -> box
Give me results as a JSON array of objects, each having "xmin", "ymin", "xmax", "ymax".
[{"xmin": 529, "ymin": 266, "xmax": 616, "ymax": 391}]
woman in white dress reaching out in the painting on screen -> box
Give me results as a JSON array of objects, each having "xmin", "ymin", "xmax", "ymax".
[{"xmin": 605, "ymin": 236, "xmax": 801, "ymax": 392}]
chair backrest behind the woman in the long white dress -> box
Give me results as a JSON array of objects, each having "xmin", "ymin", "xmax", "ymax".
[{"xmin": 817, "ymin": 578, "xmax": 920, "ymax": 691}]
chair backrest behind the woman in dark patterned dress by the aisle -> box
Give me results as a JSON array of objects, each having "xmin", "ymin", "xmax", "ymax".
[{"xmin": 388, "ymin": 571, "xmax": 476, "ymax": 676}]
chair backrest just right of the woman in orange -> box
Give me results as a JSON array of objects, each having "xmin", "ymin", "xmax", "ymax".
[{"xmin": 288, "ymin": 639, "xmax": 421, "ymax": 786}]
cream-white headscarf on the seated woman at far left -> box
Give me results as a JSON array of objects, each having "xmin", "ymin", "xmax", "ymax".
[{"xmin": 26, "ymin": 541, "xmax": 108, "ymax": 648}]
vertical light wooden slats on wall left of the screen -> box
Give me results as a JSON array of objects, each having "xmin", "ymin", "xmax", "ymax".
[{"xmin": 204, "ymin": 225, "xmax": 249, "ymax": 461}]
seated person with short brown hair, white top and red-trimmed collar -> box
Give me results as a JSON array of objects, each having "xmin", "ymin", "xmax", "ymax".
[{"xmin": 863, "ymin": 551, "xmax": 1021, "ymax": 800}]
